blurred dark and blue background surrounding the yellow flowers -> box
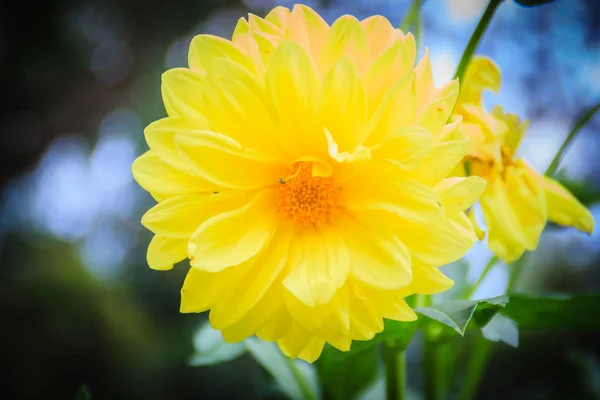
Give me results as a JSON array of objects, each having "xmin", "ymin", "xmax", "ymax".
[{"xmin": 0, "ymin": 0, "xmax": 600, "ymax": 399}]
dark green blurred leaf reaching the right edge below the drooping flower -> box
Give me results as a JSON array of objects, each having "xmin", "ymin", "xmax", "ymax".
[{"xmin": 502, "ymin": 294, "xmax": 600, "ymax": 331}]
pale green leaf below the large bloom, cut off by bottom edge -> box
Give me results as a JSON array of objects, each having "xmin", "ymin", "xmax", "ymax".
[{"xmin": 244, "ymin": 337, "xmax": 321, "ymax": 400}]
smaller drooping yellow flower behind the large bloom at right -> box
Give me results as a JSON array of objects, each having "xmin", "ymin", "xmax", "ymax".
[{"xmin": 455, "ymin": 57, "xmax": 594, "ymax": 262}]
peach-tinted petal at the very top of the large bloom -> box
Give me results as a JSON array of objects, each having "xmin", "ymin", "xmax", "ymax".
[{"xmin": 286, "ymin": 4, "xmax": 329, "ymax": 60}]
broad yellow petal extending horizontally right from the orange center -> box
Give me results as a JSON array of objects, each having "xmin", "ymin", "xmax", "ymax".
[{"xmin": 340, "ymin": 163, "xmax": 443, "ymax": 221}]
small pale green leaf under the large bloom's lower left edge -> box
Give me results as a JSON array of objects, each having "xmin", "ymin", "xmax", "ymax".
[{"xmin": 188, "ymin": 323, "xmax": 246, "ymax": 366}]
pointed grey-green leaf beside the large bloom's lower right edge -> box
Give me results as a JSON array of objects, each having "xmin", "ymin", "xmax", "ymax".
[{"xmin": 415, "ymin": 296, "xmax": 508, "ymax": 336}]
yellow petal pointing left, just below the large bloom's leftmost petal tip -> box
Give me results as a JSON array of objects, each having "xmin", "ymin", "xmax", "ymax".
[{"xmin": 142, "ymin": 191, "xmax": 248, "ymax": 239}]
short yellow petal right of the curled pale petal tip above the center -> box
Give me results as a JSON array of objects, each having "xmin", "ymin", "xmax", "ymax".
[{"xmin": 371, "ymin": 126, "xmax": 433, "ymax": 169}]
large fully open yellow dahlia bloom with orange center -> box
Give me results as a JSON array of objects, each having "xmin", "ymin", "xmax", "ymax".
[{"xmin": 133, "ymin": 6, "xmax": 485, "ymax": 361}]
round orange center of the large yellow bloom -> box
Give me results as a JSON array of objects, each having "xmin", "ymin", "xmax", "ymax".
[{"xmin": 277, "ymin": 162, "xmax": 341, "ymax": 225}]
